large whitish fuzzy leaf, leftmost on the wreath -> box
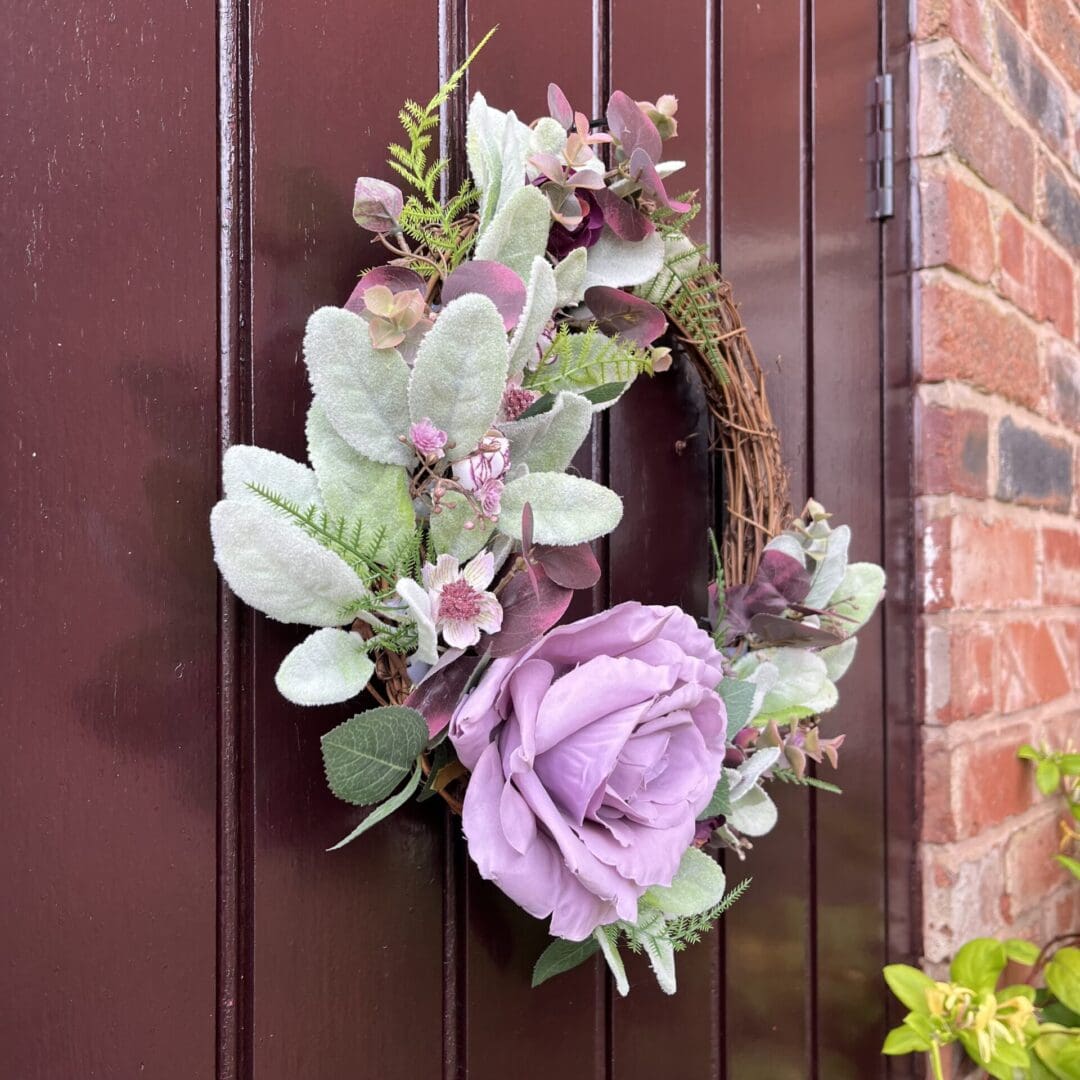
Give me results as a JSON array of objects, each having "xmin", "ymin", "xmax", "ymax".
[{"xmin": 210, "ymin": 499, "xmax": 364, "ymax": 626}]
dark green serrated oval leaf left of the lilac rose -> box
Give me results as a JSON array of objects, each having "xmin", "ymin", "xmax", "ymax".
[{"xmin": 322, "ymin": 705, "xmax": 428, "ymax": 806}]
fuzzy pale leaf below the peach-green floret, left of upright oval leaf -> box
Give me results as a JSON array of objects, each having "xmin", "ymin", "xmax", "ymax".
[{"xmin": 303, "ymin": 308, "xmax": 413, "ymax": 465}]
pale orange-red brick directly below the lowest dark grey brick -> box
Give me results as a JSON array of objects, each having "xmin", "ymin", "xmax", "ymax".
[{"xmin": 947, "ymin": 514, "xmax": 1038, "ymax": 611}]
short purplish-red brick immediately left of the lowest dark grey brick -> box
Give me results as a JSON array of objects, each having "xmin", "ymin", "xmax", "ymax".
[{"xmin": 915, "ymin": 402, "xmax": 987, "ymax": 496}]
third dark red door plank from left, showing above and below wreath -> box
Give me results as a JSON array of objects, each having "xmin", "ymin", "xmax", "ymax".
[{"xmin": 457, "ymin": 10, "xmax": 607, "ymax": 1080}]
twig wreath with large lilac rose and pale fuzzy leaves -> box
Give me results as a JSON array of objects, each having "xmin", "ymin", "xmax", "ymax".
[{"xmin": 211, "ymin": 35, "xmax": 883, "ymax": 994}]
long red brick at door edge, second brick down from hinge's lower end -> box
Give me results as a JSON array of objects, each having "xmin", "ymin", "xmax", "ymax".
[{"xmin": 919, "ymin": 281, "xmax": 1042, "ymax": 406}]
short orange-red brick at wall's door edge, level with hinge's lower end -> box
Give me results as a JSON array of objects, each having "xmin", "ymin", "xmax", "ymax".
[{"xmin": 921, "ymin": 171, "xmax": 994, "ymax": 282}]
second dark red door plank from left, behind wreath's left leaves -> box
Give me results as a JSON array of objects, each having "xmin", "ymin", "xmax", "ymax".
[{"xmin": 249, "ymin": 0, "xmax": 443, "ymax": 1080}]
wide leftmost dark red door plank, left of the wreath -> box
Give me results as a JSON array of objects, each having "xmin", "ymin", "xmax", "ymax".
[{"xmin": 0, "ymin": 0, "xmax": 218, "ymax": 1080}]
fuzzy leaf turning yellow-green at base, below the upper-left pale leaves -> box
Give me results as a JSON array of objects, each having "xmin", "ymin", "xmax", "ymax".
[{"xmin": 301, "ymin": 399, "xmax": 416, "ymax": 554}]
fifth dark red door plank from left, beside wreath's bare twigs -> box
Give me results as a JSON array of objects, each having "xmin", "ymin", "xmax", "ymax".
[{"xmin": 719, "ymin": 0, "xmax": 812, "ymax": 1080}]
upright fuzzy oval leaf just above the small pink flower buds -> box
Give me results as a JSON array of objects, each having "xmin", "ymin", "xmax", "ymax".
[{"xmin": 408, "ymin": 294, "xmax": 508, "ymax": 460}]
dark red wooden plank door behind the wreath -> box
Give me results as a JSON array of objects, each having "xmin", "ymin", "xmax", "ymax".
[{"xmin": 0, "ymin": 0, "xmax": 910, "ymax": 1080}]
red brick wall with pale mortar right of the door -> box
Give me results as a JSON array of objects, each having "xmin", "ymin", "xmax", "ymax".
[{"xmin": 912, "ymin": 0, "xmax": 1080, "ymax": 963}]
